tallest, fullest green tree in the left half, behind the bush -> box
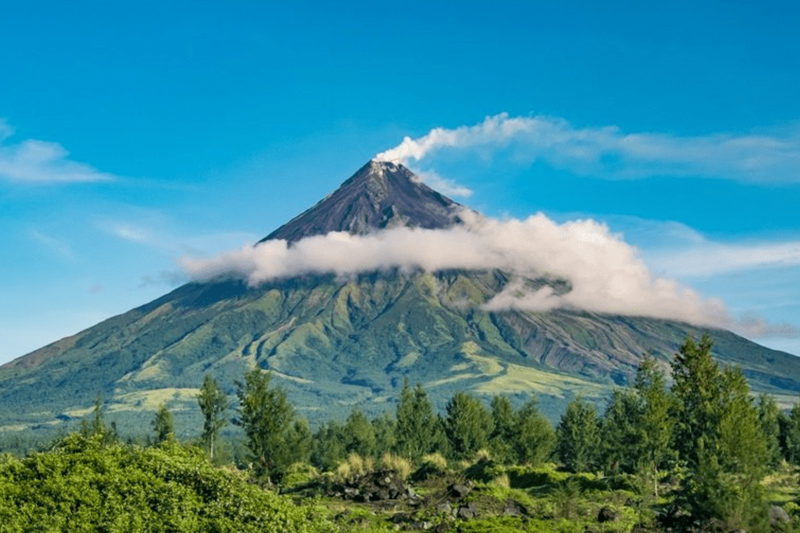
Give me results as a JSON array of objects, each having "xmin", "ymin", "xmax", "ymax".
[{"xmin": 236, "ymin": 368, "xmax": 294, "ymax": 484}]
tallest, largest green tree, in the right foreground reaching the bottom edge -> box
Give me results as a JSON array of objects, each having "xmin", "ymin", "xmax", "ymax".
[{"xmin": 673, "ymin": 335, "xmax": 767, "ymax": 530}]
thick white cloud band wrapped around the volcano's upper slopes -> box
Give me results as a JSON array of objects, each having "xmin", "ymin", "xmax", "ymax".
[{"xmin": 182, "ymin": 212, "xmax": 735, "ymax": 327}]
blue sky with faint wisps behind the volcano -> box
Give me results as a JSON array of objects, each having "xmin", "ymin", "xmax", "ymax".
[{"xmin": 0, "ymin": 1, "xmax": 800, "ymax": 362}]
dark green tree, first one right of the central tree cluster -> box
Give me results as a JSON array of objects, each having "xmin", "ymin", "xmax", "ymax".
[{"xmin": 556, "ymin": 395, "xmax": 600, "ymax": 472}]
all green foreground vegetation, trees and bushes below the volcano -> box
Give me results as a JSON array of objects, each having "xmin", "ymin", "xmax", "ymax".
[{"xmin": 0, "ymin": 337, "xmax": 800, "ymax": 532}]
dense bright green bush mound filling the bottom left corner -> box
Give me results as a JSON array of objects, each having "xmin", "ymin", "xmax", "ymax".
[{"xmin": 0, "ymin": 435, "xmax": 332, "ymax": 532}]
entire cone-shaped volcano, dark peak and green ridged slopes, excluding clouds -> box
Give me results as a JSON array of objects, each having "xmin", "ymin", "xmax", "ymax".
[{"xmin": 0, "ymin": 161, "xmax": 800, "ymax": 433}]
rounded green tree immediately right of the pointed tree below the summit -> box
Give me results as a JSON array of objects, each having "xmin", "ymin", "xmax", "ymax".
[{"xmin": 444, "ymin": 392, "xmax": 494, "ymax": 459}]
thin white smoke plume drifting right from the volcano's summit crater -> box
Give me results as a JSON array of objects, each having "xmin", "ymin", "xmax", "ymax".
[{"xmin": 376, "ymin": 113, "xmax": 800, "ymax": 183}]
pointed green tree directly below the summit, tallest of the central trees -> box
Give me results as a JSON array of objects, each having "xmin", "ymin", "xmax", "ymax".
[{"xmin": 395, "ymin": 380, "xmax": 444, "ymax": 461}]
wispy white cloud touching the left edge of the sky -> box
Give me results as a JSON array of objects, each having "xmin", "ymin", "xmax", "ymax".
[{"xmin": 0, "ymin": 119, "xmax": 116, "ymax": 184}]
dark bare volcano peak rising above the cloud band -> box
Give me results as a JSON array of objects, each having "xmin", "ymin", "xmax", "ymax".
[{"xmin": 259, "ymin": 159, "xmax": 461, "ymax": 242}]
